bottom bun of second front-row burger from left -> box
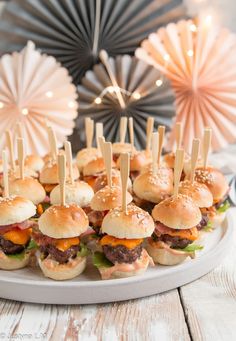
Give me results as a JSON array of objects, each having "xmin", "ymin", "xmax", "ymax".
[{"xmin": 37, "ymin": 257, "xmax": 86, "ymax": 281}]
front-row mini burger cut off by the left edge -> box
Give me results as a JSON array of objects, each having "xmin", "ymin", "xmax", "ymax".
[{"xmin": 0, "ymin": 196, "xmax": 36, "ymax": 270}]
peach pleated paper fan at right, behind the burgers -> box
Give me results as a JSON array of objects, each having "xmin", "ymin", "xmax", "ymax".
[{"xmin": 136, "ymin": 16, "xmax": 236, "ymax": 150}]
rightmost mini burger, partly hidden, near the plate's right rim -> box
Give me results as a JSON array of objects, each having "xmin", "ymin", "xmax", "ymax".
[{"xmin": 195, "ymin": 167, "xmax": 230, "ymax": 227}]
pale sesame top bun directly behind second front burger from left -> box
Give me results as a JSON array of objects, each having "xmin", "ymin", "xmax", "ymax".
[{"xmin": 50, "ymin": 181, "xmax": 94, "ymax": 207}]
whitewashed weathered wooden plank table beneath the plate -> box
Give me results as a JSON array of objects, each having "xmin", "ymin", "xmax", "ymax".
[{"xmin": 0, "ymin": 148, "xmax": 236, "ymax": 341}]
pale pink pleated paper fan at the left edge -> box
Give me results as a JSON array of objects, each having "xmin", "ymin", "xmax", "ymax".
[{"xmin": 0, "ymin": 42, "xmax": 78, "ymax": 155}]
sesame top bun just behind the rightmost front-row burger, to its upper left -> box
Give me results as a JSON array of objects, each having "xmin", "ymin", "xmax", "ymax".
[{"xmin": 133, "ymin": 168, "xmax": 173, "ymax": 203}]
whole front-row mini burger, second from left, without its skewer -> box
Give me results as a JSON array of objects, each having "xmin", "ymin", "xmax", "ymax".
[{"xmin": 33, "ymin": 204, "xmax": 88, "ymax": 280}]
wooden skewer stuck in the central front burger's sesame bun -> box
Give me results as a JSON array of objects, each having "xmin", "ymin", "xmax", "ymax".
[{"xmin": 120, "ymin": 153, "xmax": 130, "ymax": 214}]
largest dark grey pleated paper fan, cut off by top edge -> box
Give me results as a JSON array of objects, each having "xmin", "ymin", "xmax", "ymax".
[{"xmin": 0, "ymin": 0, "xmax": 185, "ymax": 84}]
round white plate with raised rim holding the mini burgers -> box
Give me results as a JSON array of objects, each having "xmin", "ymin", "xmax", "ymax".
[{"xmin": 0, "ymin": 212, "xmax": 233, "ymax": 304}]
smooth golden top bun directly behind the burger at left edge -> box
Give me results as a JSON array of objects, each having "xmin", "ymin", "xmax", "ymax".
[{"xmin": 9, "ymin": 178, "xmax": 46, "ymax": 205}]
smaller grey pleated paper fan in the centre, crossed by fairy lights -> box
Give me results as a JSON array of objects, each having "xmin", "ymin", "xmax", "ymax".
[{"xmin": 70, "ymin": 51, "xmax": 175, "ymax": 148}]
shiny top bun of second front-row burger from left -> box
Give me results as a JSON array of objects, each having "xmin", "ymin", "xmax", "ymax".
[{"xmin": 38, "ymin": 204, "xmax": 89, "ymax": 238}]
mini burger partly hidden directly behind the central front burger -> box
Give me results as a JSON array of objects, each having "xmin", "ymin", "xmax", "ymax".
[{"xmin": 84, "ymin": 186, "xmax": 133, "ymax": 233}]
